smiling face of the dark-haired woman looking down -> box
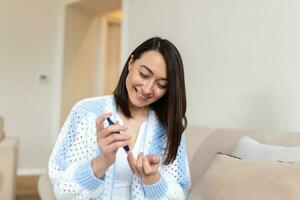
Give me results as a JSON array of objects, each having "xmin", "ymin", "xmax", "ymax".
[{"xmin": 126, "ymin": 50, "xmax": 168, "ymax": 108}]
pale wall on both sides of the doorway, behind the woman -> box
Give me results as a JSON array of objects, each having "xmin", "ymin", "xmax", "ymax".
[{"xmin": 0, "ymin": 0, "xmax": 300, "ymax": 174}]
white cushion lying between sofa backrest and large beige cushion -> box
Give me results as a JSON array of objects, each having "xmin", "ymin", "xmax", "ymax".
[{"xmin": 233, "ymin": 136, "xmax": 300, "ymax": 162}]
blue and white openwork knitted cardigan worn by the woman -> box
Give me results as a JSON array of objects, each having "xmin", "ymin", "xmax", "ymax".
[{"xmin": 49, "ymin": 95, "xmax": 191, "ymax": 200}]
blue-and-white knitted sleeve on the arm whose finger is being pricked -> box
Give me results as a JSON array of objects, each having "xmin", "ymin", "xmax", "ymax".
[{"xmin": 143, "ymin": 135, "xmax": 191, "ymax": 200}]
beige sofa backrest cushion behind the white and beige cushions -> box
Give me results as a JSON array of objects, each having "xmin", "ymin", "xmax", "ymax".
[{"xmin": 190, "ymin": 129, "xmax": 300, "ymax": 185}]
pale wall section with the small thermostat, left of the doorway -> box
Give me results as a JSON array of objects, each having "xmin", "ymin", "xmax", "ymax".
[{"xmin": 0, "ymin": 0, "xmax": 59, "ymax": 174}]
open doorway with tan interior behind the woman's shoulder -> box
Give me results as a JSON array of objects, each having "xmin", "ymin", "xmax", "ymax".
[{"xmin": 60, "ymin": 0, "xmax": 122, "ymax": 126}]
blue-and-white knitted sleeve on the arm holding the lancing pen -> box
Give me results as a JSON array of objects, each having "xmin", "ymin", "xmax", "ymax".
[{"xmin": 48, "ymin": 102, "xmax": 104, "ymax": 200}]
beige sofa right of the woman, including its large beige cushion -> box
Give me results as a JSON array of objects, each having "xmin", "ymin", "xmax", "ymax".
[{"xmin": 188, "ymin": 129, "xmax": 300, "ymax": 200}]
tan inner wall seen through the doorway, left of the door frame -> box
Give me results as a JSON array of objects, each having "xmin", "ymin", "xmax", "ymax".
[{"xmin": 61, "ymin": 6, "xmax": 99, "ymax": 125}]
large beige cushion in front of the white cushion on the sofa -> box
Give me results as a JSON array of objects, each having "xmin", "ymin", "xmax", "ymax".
[{"xmin": 190, "ymin": 155, "xmax": 300, "ymax": 200}]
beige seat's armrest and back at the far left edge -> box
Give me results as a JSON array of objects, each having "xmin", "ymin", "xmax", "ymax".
[{"xmin": 0, "ymin": 116, "xmax": 18, "ymax": 200}]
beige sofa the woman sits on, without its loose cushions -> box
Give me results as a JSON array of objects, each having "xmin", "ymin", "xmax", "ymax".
[{"xmin": 38, "ymin": 126, "xmax": 300, "ymax": 200}]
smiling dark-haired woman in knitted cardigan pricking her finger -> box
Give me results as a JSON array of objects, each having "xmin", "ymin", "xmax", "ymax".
[{"xmin": 49, "ymin": 37, "xmax": 191, "ymax": 200}]
